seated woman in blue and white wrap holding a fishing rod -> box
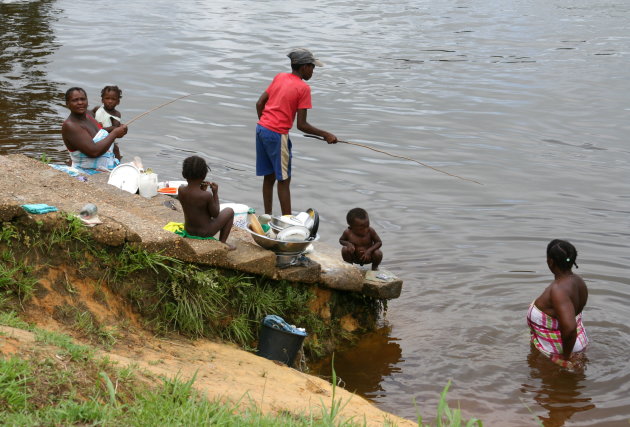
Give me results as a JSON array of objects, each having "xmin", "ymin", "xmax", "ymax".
[{"xmin": 61, "ymin": 87, "xmax": 127, "ymax": 171}]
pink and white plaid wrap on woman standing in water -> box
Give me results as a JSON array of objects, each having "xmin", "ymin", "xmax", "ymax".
[{"xmin": 527, "ymin": 302, "xmax": 588, "ymax": 368}]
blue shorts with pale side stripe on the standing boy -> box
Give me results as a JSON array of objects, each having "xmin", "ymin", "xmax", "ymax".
[{"xmin": 256, "ymin": 125, "xmax": 293, "ymax": 181}]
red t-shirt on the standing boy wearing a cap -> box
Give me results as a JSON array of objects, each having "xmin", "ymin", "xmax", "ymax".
[{"xmin": 258, "ymin": 73, "xmax": 313, "ymax": 135}]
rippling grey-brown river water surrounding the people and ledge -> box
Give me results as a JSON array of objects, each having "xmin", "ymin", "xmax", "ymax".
[{"xmin": 0, "ymin": 0, "xmax": 630, "ymax": 426}]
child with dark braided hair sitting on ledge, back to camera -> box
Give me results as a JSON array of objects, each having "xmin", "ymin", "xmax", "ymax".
[{"xmin": 178, "ymin": 156, "xmax": 236, "ymax": 251}]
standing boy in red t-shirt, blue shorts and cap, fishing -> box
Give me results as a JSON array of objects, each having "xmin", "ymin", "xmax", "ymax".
[{"xmin": 256, "ymin": 49, "xmax": 337, "ymax": 215}]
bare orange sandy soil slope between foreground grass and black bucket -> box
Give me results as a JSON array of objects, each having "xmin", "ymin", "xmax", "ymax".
[{"xmin": 0, "ymin": 326, "xmax": 416, "ymax": 426}]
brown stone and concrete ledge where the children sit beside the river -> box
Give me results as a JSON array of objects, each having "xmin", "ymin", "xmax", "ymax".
[{"xmin": 0, "ymin": 154, "xmax": 402, "ymax": 299}]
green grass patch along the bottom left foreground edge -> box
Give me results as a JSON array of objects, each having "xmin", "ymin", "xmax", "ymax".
[{"xmin": 0, "ymin": 353, "xmax": 370, "ymax": 427}]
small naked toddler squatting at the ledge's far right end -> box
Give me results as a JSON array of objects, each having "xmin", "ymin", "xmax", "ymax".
[{"xmin": 339, "ymin": 208, "xmax": 383, "ymax": 270}]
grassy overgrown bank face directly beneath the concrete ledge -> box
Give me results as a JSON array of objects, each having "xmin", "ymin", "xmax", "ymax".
[{"xmin": 0, "ymin": 214, "xmax": 384, "ymax": 358}]
